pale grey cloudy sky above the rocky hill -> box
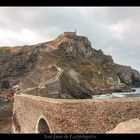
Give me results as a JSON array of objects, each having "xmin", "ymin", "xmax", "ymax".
[{"xmin": 0, "ymin": 7, "xmax": 140, "ymax": 71}]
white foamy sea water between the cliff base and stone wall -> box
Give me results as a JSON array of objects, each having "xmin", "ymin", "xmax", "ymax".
[{"xmin": 92, "ymin": 88, "xmax": 140, "ymax": 99}]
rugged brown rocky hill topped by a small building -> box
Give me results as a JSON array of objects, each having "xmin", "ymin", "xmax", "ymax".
[{"xmin": 0, "ymin": 35, "xmax": 140, "ymax": 99}]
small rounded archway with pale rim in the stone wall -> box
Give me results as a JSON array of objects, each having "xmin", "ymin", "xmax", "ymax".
[{"xmin": 36, "ymin": 116, "xmax": 51, "ymax": 133}]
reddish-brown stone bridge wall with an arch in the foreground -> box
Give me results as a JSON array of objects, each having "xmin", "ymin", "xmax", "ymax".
[{"xmin": 13, "ymin": 94, "xmax": 140, "ymax": 133}]
